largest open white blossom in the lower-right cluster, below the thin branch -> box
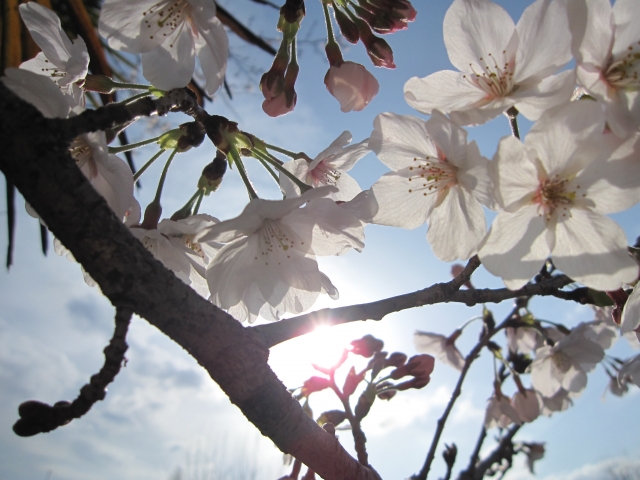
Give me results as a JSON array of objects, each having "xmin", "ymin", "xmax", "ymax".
[{"xmin": 531, "ymin": 330, "xmax": 604, "ymax": 397}]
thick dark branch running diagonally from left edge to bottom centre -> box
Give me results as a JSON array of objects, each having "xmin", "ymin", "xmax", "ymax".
[{"xmin": 0, "ymin": 82, "xmax": 379, "ymax": 480}]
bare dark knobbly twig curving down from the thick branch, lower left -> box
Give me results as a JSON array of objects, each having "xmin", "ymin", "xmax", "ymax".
[{"xmin": 13, "ymin": 308, "xmax": 132, "ymax": 437}]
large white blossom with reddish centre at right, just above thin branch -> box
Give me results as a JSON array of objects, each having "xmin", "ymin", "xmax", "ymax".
[{"xmin": 478, "ymin": 101, "xmax": 638, "ymax": 290}]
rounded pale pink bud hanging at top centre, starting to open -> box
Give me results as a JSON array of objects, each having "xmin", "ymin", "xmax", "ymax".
[{"xmin": 324, "ymin": 62, "xmax": 380, "ymax": 112}]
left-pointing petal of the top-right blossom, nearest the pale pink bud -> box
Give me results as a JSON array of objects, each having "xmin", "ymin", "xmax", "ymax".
[{"xmin": 404, "ymin": 70, "xmax": 490, "ymax": 120}]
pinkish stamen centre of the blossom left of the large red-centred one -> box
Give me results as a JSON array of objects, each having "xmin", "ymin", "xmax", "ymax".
[{"xmin": 409, "ymin": 152, "xmax": 458, "ymax": 197}]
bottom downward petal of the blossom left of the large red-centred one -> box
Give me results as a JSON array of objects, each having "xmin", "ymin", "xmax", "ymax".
[{"xmin": 427, "ymin": 187, "xmax": 487, "ymax": 262}]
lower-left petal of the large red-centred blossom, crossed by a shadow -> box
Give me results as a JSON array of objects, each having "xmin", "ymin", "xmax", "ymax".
[{"xmin": 478, "ymin": 205, "xmax": 549, "ymax": 290}]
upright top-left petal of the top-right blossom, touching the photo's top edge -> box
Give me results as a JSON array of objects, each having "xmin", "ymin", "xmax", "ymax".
[{"xmin": 442, "ymin": 0, "xmax": 515, "ymax": 72}]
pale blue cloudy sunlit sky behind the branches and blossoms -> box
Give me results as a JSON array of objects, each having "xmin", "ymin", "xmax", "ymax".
[{"xmin": 0, "ymin": 0, "xmax": 640, "ymax": 480}]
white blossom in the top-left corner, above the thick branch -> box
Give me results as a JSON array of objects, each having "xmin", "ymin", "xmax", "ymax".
[{"xmin": 20, "ymin": 2, "xmax": 89, "ymax": 101}]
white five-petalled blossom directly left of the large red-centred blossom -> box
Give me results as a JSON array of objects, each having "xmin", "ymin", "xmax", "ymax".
[{"xmin": 369, "ymin": 111, "xmax": 492, "ymax": 262}]
